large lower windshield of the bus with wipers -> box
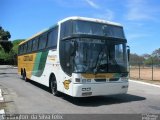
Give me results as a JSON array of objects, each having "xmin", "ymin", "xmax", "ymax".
[{"xmin": 60, "ymin": 38, "xmax": 127, "ymax": 74}]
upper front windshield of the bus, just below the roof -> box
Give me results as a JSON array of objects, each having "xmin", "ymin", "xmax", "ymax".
[{"xmin": 73, "ymin": 20, "xmax": 125, "ymax": 39}]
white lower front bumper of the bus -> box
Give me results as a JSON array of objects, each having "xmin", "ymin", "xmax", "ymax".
[{"xmin": 72, "ymin": 82, "xmax": 128, "ymax": 97}]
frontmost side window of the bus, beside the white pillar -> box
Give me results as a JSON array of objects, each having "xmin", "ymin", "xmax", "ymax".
[{"xmin": 47, "ymin": 27, "xmax": 58, "ymax": 48}]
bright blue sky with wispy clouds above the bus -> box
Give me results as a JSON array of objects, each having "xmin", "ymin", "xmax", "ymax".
[{"xmin": 0, "ymin": 0, "xmax": 160, "ymax": 55}]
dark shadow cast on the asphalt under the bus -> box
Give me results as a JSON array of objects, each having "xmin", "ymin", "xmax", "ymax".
[{"xmin": 26, "ymin": 81, "xmax": 146, "ymax": 107}]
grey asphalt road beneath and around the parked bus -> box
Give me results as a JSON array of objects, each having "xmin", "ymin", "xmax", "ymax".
[{"xmin": 0, "ymin": 66, "xmax": 160, "ymax": 114}]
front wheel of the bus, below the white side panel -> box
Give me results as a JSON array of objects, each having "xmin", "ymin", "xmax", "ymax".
[{"xmin": 50, "ymin": 77, "xmax": 59, "ymax": 96}]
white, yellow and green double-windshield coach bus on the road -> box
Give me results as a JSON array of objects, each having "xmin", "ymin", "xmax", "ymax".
[{"xmin": 18, "ymin": 16, "xmax": 129, "ymax": 97}]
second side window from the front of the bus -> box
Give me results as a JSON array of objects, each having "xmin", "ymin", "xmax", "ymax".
[{"xmin": 38, "ymin": 33, "xmax": 47, "ymax": 50}]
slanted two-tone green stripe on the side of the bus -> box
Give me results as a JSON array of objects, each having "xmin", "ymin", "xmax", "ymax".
[{"xmin": 32, "ymin": 51, "xmax": 48, "ymax": 77}]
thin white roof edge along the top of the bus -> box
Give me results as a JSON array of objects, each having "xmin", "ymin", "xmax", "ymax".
[{"xmin": 19, "ymin": 16, "xmax": 122, "ymax": 45}]
